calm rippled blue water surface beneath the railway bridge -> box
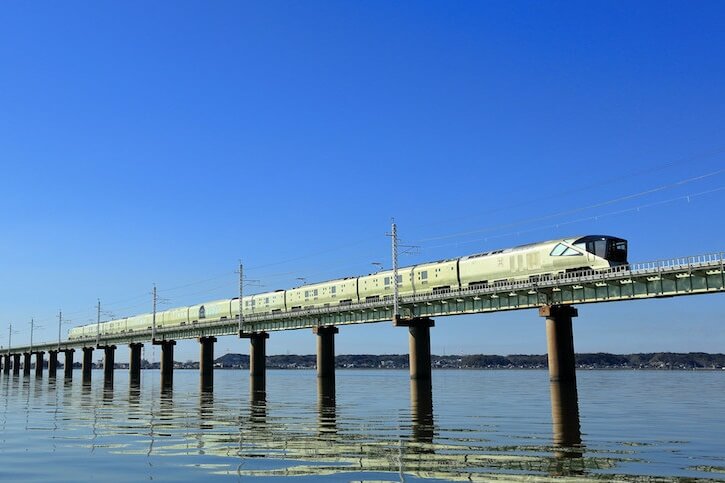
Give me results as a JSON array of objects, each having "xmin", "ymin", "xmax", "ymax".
[{"xmin": 0, "ymin": 370, "xmax": 725, "ymax": 482}]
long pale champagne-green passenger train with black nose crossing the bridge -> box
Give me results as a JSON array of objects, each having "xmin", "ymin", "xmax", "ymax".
[{"xmin": 68, "ymin": 235, "xmax": 628, "ymax": 340}]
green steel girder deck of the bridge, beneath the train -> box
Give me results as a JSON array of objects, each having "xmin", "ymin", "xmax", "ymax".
[{"xmin": 3, "ymin": 252, "xmax": 725, "ymax": 354}]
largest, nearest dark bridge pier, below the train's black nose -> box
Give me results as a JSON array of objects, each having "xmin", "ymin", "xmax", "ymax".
[{"xmin": 539, "ymin": 305, "xmax": 577, "ymax": 384}]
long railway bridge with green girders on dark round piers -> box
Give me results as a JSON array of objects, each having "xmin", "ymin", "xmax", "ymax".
[{"xmin": 2, "ymin": 252, "xmax": 725, "ymax": 450}]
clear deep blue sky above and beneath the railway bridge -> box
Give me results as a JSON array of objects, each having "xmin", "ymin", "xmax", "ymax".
[{"xmin": 0, "ymin": 1, "xmax": 725, "ymax": 360}]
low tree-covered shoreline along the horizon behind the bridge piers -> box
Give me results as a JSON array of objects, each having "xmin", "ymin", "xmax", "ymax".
[{"xmin": 214, "ymin": 352, "xmax": 725, "ymax": 370}]
